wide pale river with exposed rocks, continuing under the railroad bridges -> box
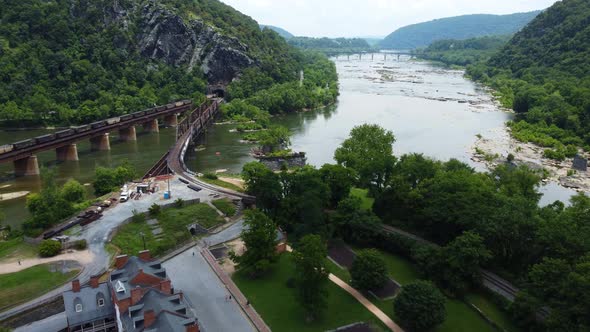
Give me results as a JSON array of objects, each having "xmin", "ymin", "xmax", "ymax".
[{"xmin": 0, "ymin": 54, "xmax": 574, "ymax": 230}]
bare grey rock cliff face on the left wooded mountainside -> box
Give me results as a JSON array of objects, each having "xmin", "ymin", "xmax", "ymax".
[{"xmin": 105, "ymin": 0, "xmax": 255, "ymax": 84}]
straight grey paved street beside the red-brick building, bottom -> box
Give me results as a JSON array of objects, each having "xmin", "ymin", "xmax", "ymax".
[{"xmin": 164, "ymin": 226, "xmax": 256, "ymax": 332}]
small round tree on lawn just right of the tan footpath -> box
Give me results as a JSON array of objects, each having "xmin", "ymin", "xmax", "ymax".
[{"xmin": 350, "ymin": 249, "xmax": 388, "ymax": 290}]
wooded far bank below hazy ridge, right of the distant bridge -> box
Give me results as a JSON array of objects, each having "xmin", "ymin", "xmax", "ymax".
[{"xmin": 414, "ymin": 36, "xmax": 511, "ymax": 67}]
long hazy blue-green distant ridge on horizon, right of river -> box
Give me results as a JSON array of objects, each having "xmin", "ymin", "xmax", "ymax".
[{"xmin": 380, "ymin": 11, "xmax": 540, "ymax": 50}]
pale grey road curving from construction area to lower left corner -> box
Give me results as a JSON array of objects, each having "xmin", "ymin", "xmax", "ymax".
[{"xmin": 0, "ymin": 177, "xmax": 224, "ymax": 320}]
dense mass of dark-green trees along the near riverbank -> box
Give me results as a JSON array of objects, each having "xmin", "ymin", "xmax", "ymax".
[{"xmin": 243, "ymin": 125, "xmax": 590, "ymax": 331}]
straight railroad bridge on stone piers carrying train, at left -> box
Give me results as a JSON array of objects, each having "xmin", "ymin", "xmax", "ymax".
[{"xmin": 0, "ymin": 100, "xmax": 193, "ymax": 176}]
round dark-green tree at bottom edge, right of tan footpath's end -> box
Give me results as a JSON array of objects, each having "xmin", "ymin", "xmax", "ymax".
[{"xmin": 393, "ymin": 281, "xmax": 447, "ymax": 331}]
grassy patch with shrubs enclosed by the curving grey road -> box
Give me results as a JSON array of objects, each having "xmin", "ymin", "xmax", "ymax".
[{"xmin": 112, "ymin": 204, "xmax": 224, "ymax": 256}]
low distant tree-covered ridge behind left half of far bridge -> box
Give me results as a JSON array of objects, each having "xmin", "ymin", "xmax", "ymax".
[{"xmin": 289, "ymin": 37, "xmax": 374, "ymax": 55}]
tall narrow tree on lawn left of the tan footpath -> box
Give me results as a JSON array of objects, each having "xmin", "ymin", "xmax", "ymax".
[{"xmin": 293, "ymin": 235, "xmax": 328, "ymax": 321}]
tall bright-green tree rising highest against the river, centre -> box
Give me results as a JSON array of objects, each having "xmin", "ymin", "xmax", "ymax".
[{"xmin": 334, "ymin": 124, "xmax": 396, "ymax": 192}]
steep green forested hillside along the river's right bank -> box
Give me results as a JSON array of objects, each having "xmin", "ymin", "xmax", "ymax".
[{"xmin": 468, "ymin": 0, "xmax": 590, "ymax": 159}]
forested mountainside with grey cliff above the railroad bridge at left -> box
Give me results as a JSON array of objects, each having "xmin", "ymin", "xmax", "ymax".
[{"xmin": 0, "ymin": 0, "xmax": 320, "ymax": 125}]
